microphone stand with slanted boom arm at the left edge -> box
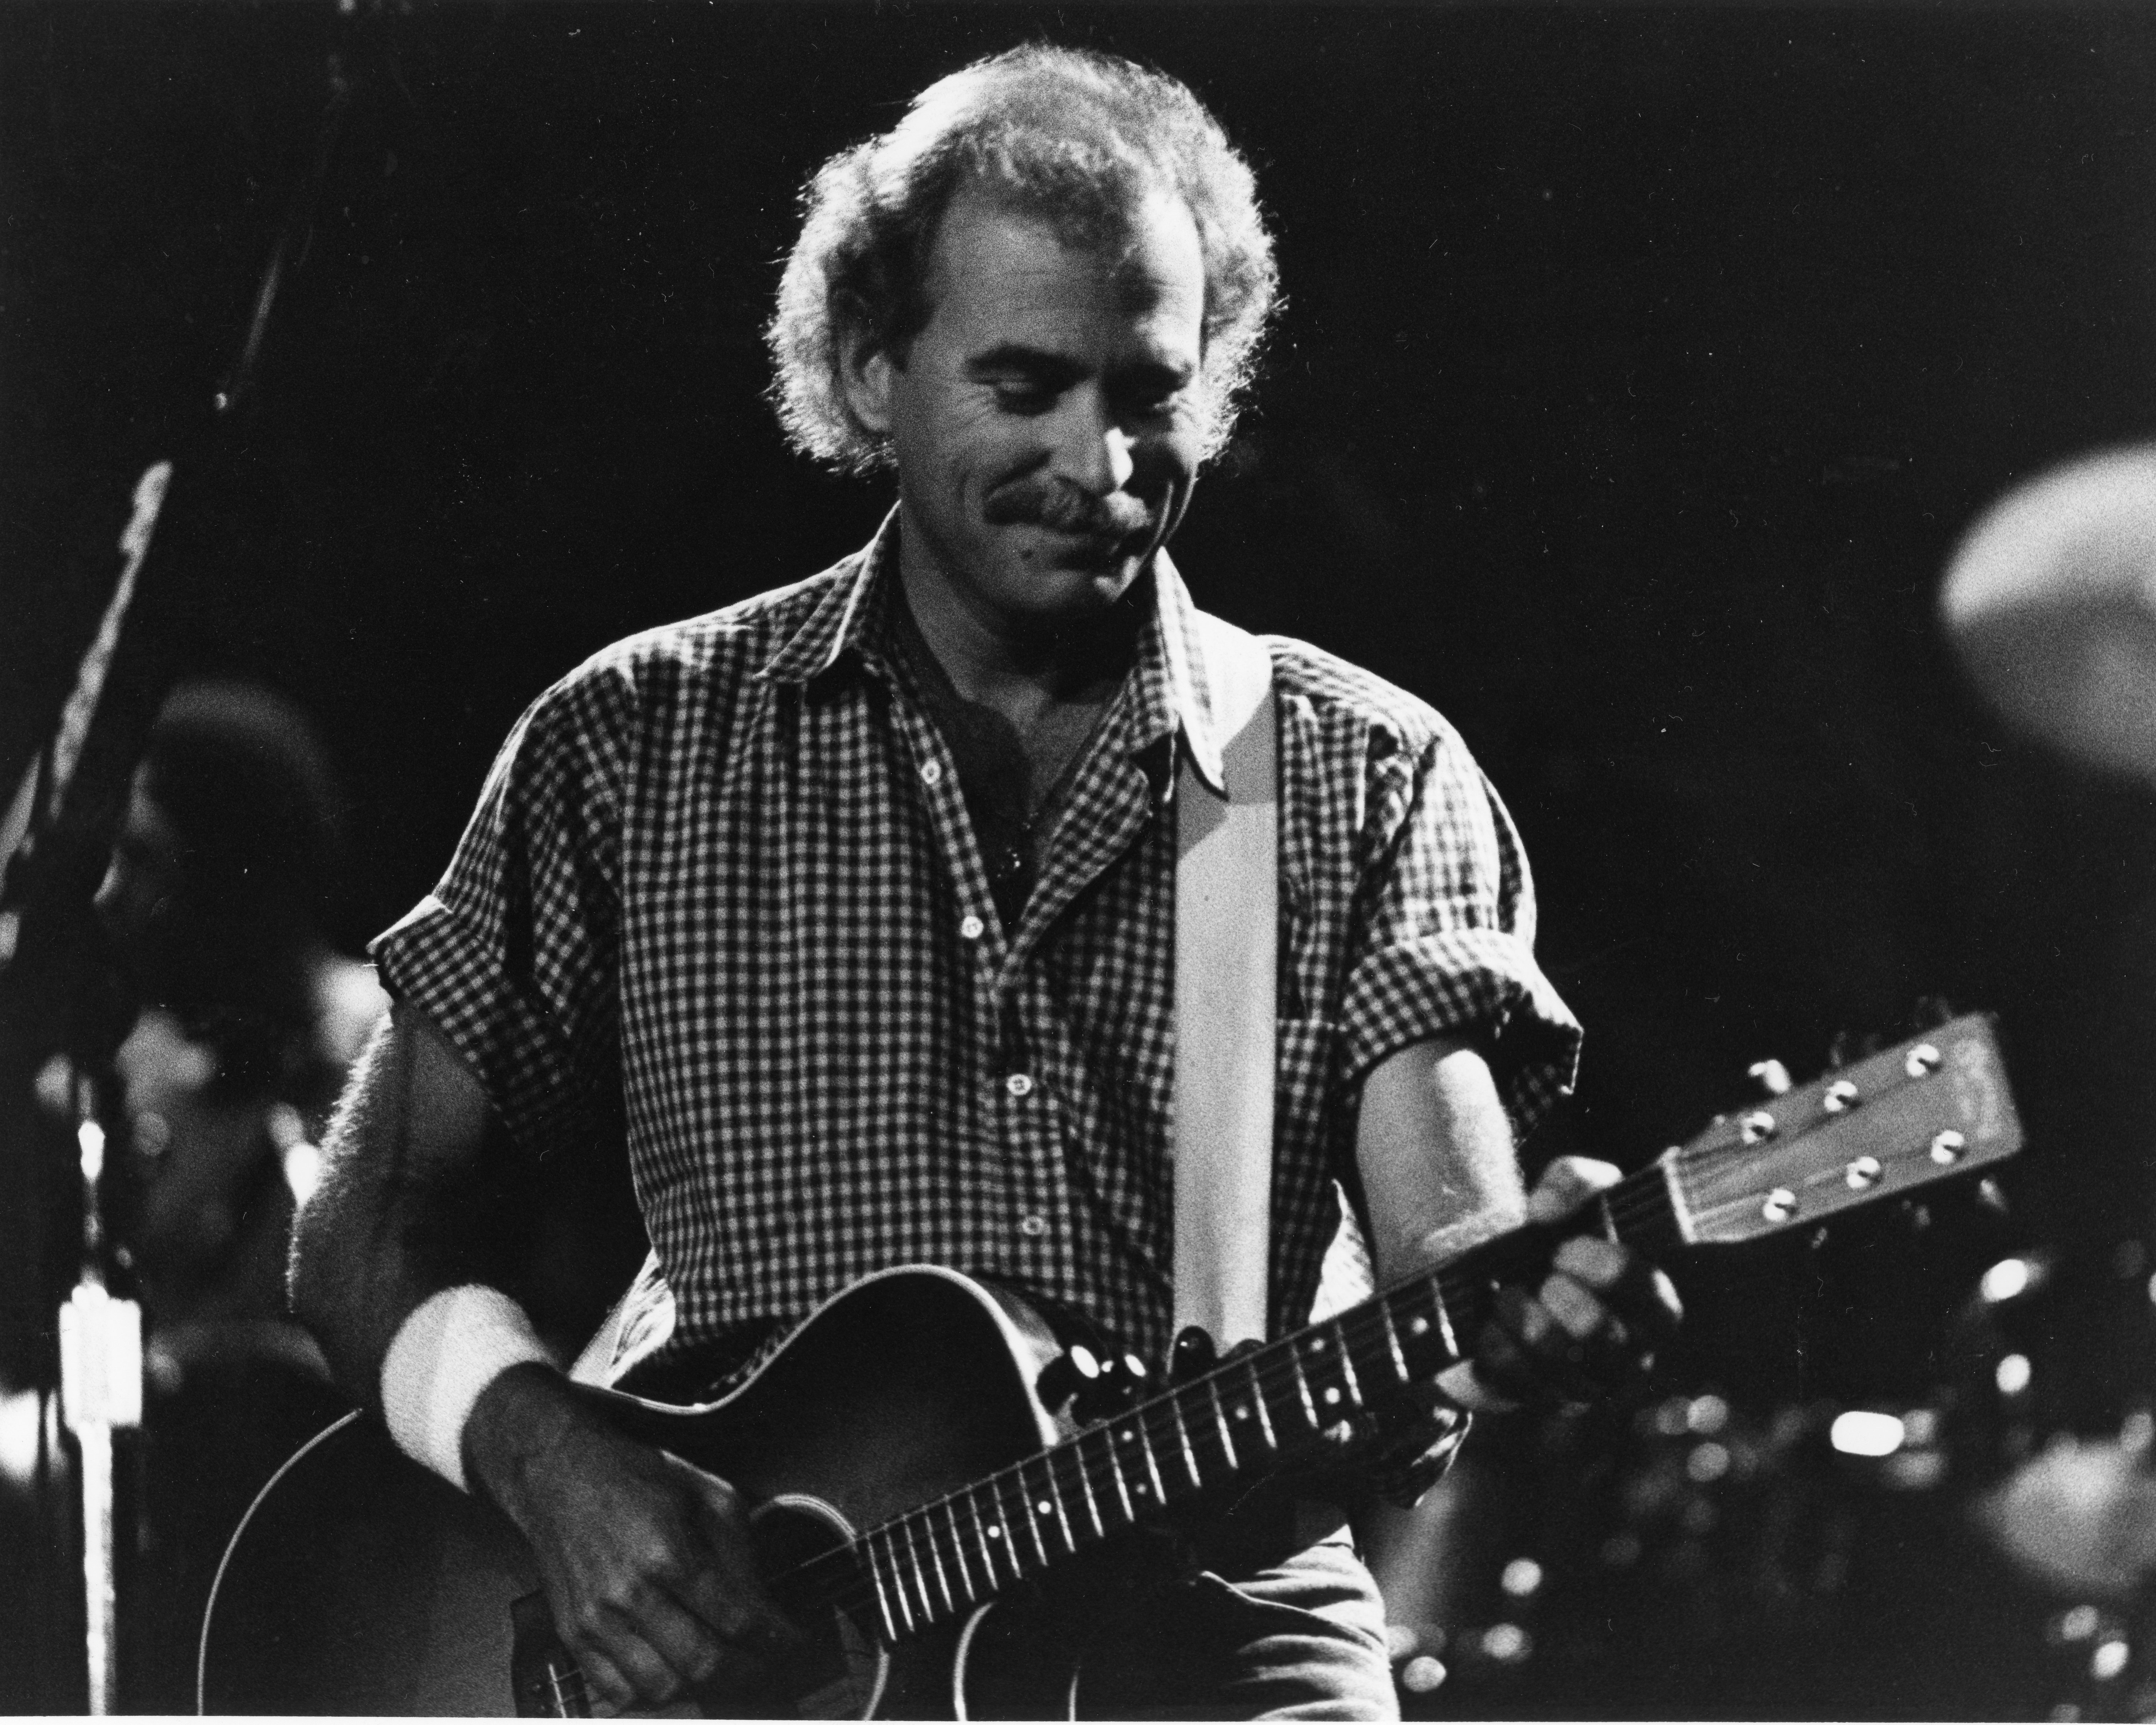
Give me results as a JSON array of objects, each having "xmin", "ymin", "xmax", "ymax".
[{"xmin": 0, "ymin": 40, "xmax": 351, "ymax": 1714}]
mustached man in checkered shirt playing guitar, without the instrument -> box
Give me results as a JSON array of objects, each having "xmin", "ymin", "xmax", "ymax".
[{"xmin": 293, "ymin": 47, "xmax": 1675, "ymax": 1718}]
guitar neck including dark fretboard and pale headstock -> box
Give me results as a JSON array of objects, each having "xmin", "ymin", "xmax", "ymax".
[{"xmin": 793, "ymin": 1013, "xmax": 2022, "ymax": 1643}]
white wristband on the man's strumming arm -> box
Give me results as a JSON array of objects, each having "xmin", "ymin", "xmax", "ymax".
[{"xmin": 381, "ymin": 1283, "xmax": 556, "ymax": 1492}]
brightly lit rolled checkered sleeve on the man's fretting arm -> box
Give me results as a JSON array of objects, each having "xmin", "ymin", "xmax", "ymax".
[{"xmin": 1341, "ymin": 735, "xmax": 1580, "ymax": 1134}]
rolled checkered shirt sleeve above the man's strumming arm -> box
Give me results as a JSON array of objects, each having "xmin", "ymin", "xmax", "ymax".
[{"xmin": 373, "ymin": 666, "xmax": 621, "ymax": 1153}]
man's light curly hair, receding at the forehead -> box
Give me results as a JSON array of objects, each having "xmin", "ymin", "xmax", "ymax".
[{"xmin": 765, "ymin": 45, "xmax": 1279, "ymax": 472}]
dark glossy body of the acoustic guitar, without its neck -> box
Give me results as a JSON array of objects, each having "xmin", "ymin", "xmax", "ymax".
[{"xmin": 201, "ymin": 1268, "xmax": 1071, "ymax": 1718}]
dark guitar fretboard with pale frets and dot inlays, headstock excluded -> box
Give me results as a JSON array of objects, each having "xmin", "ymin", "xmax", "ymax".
[{"xmin": 774, "ymin": 1164, "xmax": 1677, "ymax": 1643}]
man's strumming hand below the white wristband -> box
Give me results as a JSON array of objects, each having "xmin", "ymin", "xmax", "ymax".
[{"xmin": 464, "ymin": 1365, "xmax": 796, "ymax": 1712}]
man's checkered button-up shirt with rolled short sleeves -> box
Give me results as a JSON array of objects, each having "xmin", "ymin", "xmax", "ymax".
[{"xmin": 375, "ymin": 528, "xmax": 1578, "ymax": 1354}]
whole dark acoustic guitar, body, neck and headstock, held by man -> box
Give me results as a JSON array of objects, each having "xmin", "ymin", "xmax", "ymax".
[{"xmin": 198, "ymin": 1015, "xmax": 2022, "ymax": 1718}]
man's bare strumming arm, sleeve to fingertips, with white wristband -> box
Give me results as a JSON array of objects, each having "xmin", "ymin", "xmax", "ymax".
[{"xmin": 291, "ymin": 1005, "xmax": 793, "ymax": 1712}]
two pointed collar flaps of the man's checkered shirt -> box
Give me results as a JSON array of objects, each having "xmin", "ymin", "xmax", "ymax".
[{"xmin": 757, "ymin": 509, "xmax": 1227, "ymax": 796}]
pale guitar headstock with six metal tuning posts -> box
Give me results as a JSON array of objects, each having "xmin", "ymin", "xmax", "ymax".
[{"xmin": 1662, "ymin": 1013, "xmax": 2022, "ymax": 1244}]
